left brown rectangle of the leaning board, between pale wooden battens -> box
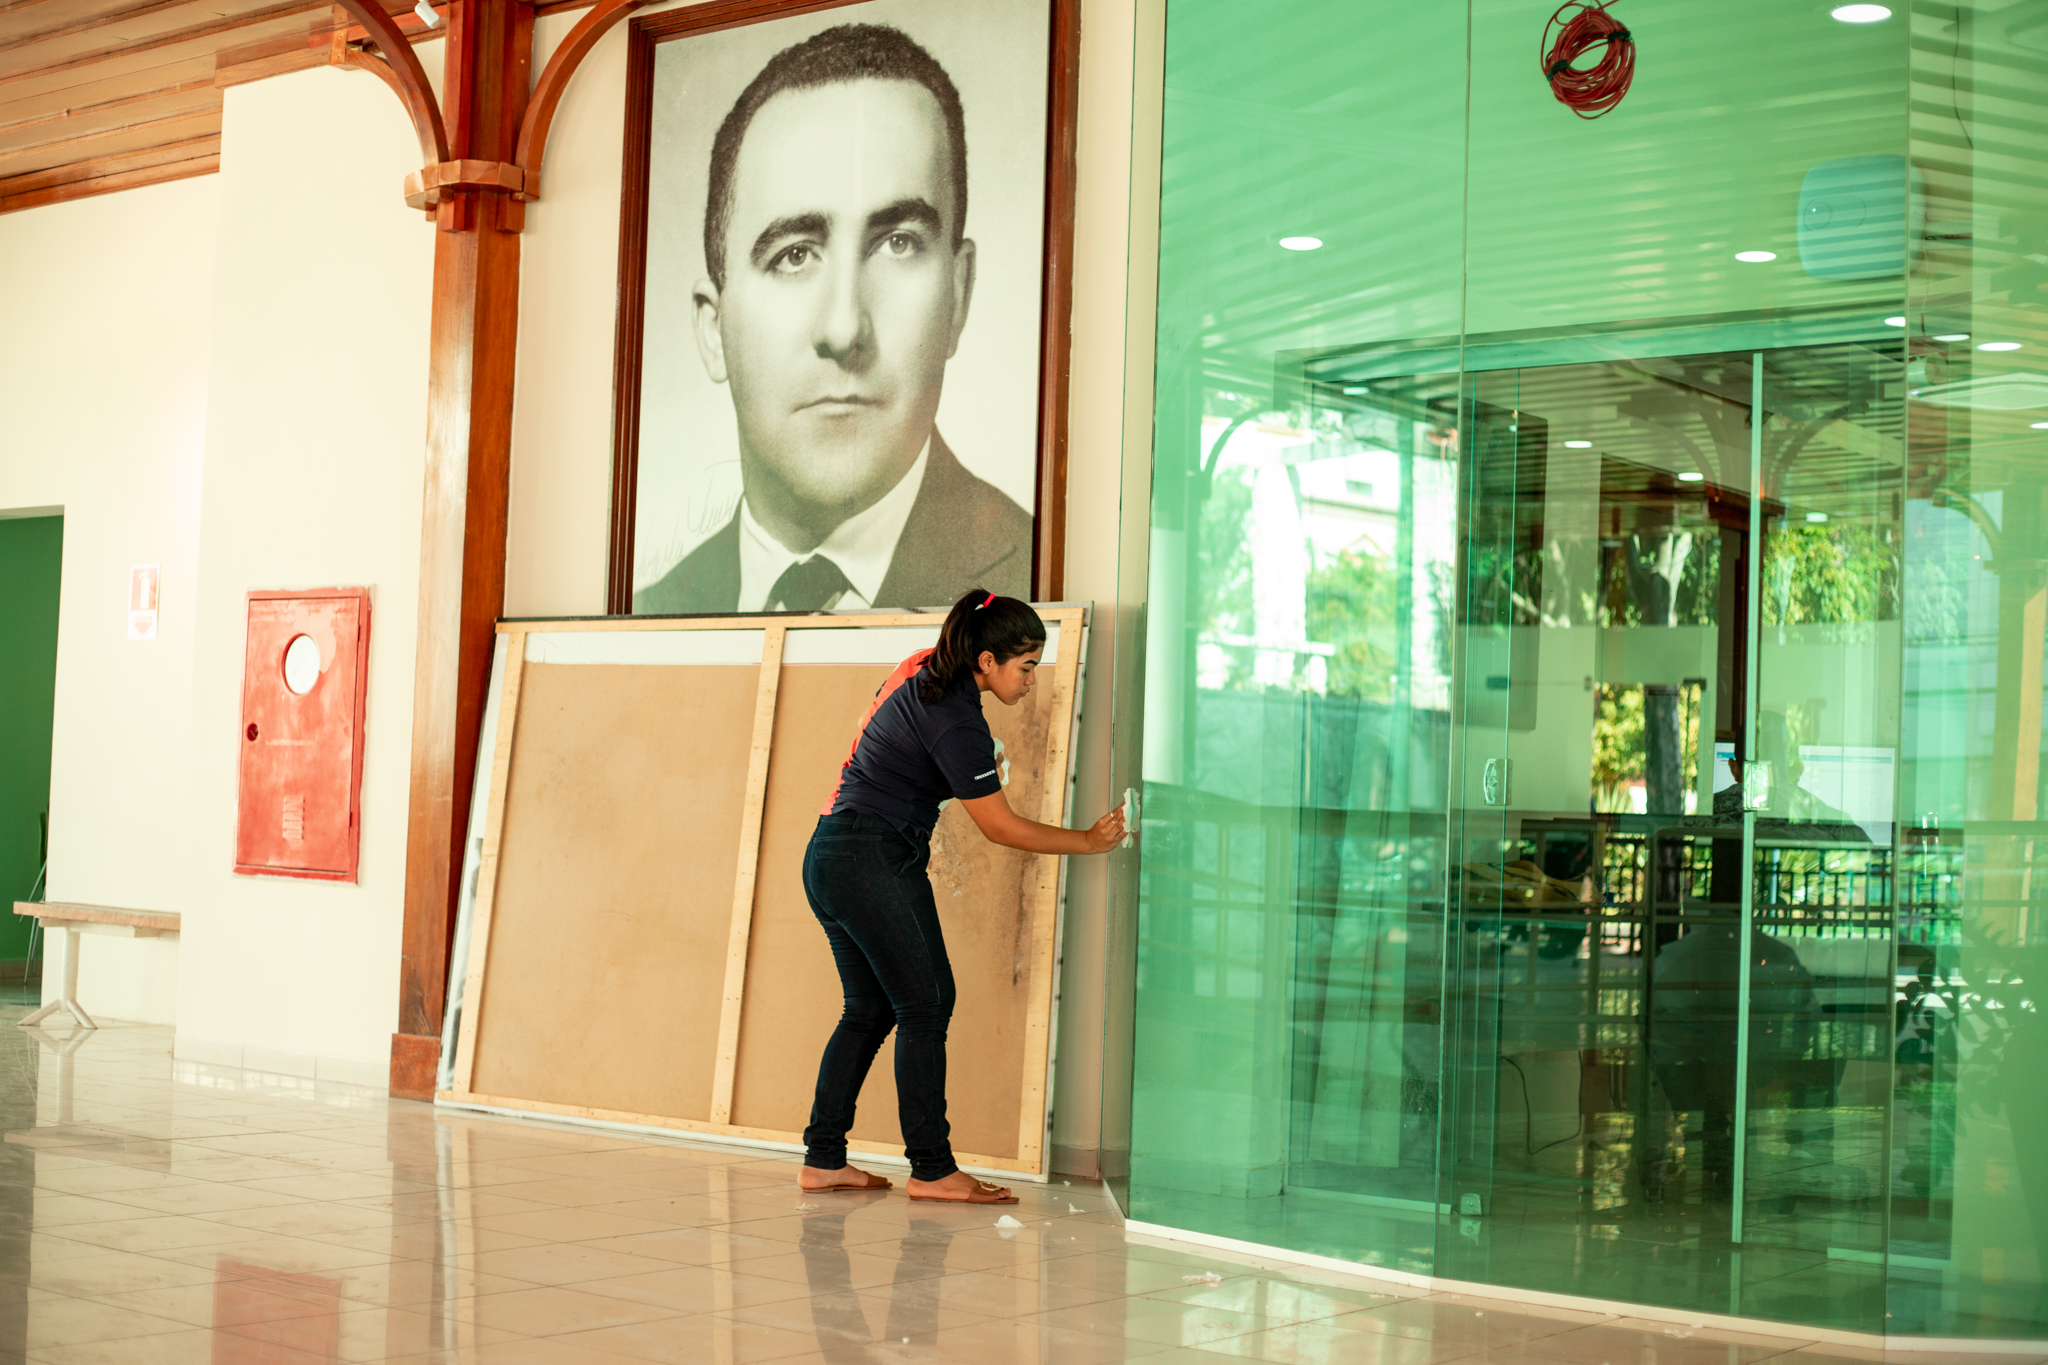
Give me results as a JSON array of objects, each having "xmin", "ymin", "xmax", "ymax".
[{"xmin": 471, "ymin": 663, "xmax": 760, "ymax": 1119}]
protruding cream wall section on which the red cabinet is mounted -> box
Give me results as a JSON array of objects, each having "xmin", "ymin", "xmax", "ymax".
[{"xmin": 178, "ymin": 66, "xmax": 438, "ymax": 1085}]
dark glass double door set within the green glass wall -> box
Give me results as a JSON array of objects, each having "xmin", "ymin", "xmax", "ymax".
[{"xmin": 1438, "ymin": 338, "xmax": 1903, "ymax": 1330}]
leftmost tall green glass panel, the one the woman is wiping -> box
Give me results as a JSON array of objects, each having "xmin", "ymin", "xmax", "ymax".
[{"xmin": 1130, "ymin": 4, "xmax": 1464, "ymax": 1269}]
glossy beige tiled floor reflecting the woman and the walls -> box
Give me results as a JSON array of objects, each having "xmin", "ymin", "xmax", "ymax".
[{"xmin": 0, "ymin": 1005, "xmax": 2025, "ymax": 1365}]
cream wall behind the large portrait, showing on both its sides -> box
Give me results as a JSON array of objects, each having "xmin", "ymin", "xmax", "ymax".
[{"xmin": 506, "ymin": 0, "xmax": 1149, "ymax": 1173}]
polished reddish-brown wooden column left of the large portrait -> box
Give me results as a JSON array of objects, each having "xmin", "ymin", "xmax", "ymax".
[{"xmin": 391, "ymin": 0, "xmax": 532, "ymax": 1099}]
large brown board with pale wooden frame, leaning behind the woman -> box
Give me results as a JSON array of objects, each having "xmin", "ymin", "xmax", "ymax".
[{"xmin": 438, "ymin": 606, "xmax": 1085, "ymax": 1177}]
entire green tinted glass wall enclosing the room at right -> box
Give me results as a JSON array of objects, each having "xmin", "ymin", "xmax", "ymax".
[{"xmin": 1112, "ymin": 0, "xmax": 2048, "ymax": 1338}]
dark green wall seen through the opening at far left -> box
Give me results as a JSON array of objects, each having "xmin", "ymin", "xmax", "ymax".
[{"xmin": 0, "ymin": 516, "xmax": 61, "ymax": 962}]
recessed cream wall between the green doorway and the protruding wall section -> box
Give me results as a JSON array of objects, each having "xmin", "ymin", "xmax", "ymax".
[{"xmin": 0, "ymin": 176, "xmax": 219, "ymax": 1023}]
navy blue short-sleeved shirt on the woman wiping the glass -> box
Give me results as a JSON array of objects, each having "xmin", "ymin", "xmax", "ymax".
[{"xmin": 823, "ymin": 649, "xmax": 1004, "ymax": 833}]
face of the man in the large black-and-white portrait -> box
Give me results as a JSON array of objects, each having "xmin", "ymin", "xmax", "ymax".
[{"xmin": 694, "ymin": 80, "xmax": 975, "ymax": 548}]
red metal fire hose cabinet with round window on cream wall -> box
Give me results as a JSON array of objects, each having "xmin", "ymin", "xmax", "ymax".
[{"xmin": 236, "ymin": 587, "xmax": 371, "ymax": 882}]
